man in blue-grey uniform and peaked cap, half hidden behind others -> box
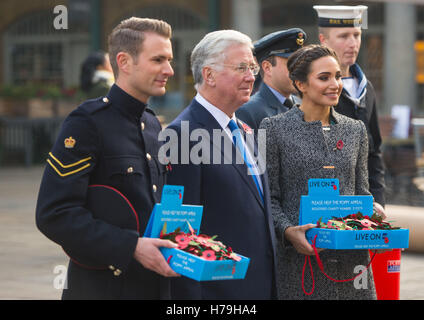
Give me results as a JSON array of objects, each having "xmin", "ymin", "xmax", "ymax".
[{"xmin": 236, "ymin": 28, "xmax": 306, "ymax": 133}]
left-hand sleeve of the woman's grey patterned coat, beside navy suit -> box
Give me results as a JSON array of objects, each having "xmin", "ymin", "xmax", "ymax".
[{"xmin": 260, "ymin": 118, "xmax": 297, "ymax": 245}]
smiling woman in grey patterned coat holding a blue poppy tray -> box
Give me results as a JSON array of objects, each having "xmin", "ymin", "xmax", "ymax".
[{"xmin": 260, "ymin": 45, "xmax": 375, "ymax": 300}]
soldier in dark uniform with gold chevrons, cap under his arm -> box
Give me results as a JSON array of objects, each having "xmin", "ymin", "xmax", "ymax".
[{"xmin": 36, "ymin": 18, "xmax": 177, "ymax": 299}]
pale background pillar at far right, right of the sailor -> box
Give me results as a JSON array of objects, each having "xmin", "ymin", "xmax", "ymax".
[{"xmin": 382, "ymin": 3, "xmax": 417, "ymax": 114}]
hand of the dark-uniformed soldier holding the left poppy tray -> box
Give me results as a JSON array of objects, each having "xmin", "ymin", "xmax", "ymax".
[{"xmin": 134, "ymin": 238, "xmax": 180, "ymax": 277}]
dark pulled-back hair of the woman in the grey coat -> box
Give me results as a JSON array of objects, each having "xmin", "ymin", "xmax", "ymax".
[{"xmin": 287, "ymin": 44, "xmax": 340, "ymax": 97}]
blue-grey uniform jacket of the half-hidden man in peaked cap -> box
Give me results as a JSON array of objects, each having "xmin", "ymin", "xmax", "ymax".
[{"xmin": 236, "ymin": 83, "xmax": 289, "ymax": 132}]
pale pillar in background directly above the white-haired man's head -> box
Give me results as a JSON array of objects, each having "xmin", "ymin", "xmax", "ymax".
[{"xmin": 232, "ymin": 0, "xmax": 261, "ymax": 41}]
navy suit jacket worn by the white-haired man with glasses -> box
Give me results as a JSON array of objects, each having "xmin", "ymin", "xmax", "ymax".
[{"xmin": 168, "ymin": 100, "xmax": 276, "ymax": 299}]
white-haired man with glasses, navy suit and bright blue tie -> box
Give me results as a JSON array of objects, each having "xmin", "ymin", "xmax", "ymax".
[{"xmin": 167, "ymin": 30, "xmax": 276, "ymax": 299}]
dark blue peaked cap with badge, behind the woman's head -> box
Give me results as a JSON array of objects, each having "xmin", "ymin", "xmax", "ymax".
[{"xmin": 254, "ymin": 28, "xmax": 306, "ymax": 63}]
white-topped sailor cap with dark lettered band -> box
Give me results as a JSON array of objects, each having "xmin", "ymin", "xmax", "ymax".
[{"xmin": 313, "ymin": 6, "xmax": 368, "ymax": 28}]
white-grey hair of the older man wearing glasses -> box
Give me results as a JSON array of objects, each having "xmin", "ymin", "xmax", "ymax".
[{"xmin": 191, "ymin": 30, "xmax": 253, "ymax": 89}]
